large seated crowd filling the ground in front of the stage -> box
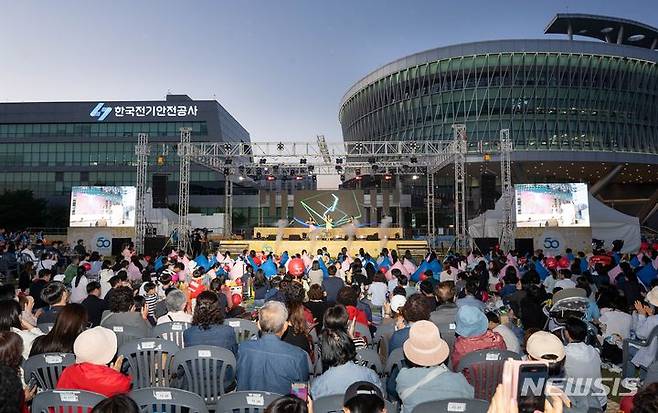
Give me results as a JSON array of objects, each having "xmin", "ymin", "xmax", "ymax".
[{"xmin": 0, "ymin": 230, "xmax": 658, "ymax": 413}]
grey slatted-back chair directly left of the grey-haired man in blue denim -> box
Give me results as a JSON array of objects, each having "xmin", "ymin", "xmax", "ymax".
[{"xmin": 171, "ymin": 346, "xmax": 237, "ymax": 409}]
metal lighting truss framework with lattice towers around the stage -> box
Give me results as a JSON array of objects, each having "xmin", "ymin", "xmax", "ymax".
[{"xmin": 135, "ymin": 124, "xmax": 514, "ymax": 251}]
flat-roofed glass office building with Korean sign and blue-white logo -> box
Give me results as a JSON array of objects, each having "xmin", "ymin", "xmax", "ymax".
[{"xmin": 0, "ymin": 95, "xmax": 257, "ymax": 225}]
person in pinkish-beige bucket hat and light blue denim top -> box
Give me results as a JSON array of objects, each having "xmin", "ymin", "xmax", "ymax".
[{"xmin": 396, "ymin": 320, "xmax": 475, "ymax": 413}]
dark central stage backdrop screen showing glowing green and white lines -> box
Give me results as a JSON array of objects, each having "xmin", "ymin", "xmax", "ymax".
[{"xmin": 293, "ymin": 189, "xmax": 365, "ymax": 228}]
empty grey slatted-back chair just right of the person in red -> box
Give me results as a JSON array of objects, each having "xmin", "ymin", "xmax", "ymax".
[{"xmin": 117, "ymin": 338, "xmax": 178, "ymax": 389}]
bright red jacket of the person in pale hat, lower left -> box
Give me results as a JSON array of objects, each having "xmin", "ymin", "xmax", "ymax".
[{"xmin": 55, "ymin": 363, "xmax": 132, "ymax": 397}]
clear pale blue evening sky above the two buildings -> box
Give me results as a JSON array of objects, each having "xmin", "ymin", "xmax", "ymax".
[{"xmin": 0, "ymin": 0, "xmax": 658, "ymax": 141}]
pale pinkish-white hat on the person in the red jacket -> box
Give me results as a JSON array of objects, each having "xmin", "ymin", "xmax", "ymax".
[{"xmin": 73, "ymin": 327, "xmax": 117, "ymax": 365}]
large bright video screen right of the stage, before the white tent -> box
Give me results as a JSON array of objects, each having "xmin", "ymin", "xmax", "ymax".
[{"xmin": 514, "ymin": 183, "xmax": 590, "ymax": 227}]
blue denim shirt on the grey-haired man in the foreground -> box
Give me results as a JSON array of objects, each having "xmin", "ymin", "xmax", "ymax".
[{"xmin": 237, "ymin": 334, "xmax": 308, "ymax": 394}]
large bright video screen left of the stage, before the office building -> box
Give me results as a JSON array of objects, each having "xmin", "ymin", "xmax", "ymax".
[{"xmin": 70, "ymin": 186, "xmax": 137, "ymax": 227}]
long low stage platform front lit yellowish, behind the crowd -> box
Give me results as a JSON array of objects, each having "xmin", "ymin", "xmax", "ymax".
[{"xmin": 218, "ymin": 237, "xmax": 429, "ymax": 257}]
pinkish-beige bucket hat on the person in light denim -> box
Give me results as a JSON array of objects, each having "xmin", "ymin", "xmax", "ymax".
[{"xmin": 403, "ymin": 320, "xmax": 450, "ymax": 367}]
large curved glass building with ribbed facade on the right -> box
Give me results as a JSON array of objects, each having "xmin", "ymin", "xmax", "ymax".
[{"xmin": 339, "ymin": 14, "xmax": 658, "ymax": 229}]
